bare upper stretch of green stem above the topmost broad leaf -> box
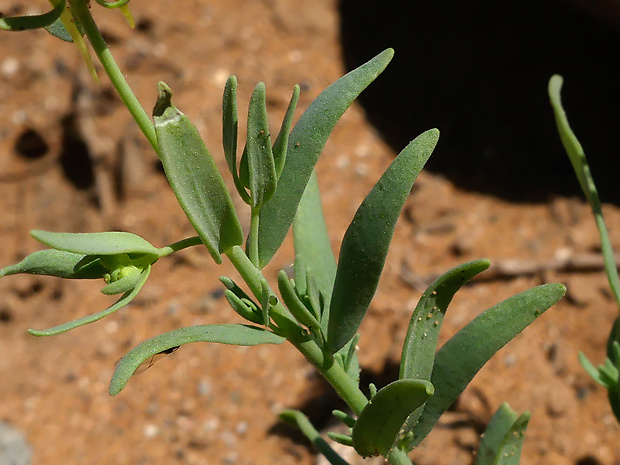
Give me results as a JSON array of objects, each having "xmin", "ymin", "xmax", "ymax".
[{"xmin": 70, "ymin": 0, "xmax": 158, "ymax": 152}]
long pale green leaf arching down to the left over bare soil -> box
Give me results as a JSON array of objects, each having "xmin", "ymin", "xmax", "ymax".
[{"xmin": 110, "ymin": 324, "xmax": 286, "ymax": 396}]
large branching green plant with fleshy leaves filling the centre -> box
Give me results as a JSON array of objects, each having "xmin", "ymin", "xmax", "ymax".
[{"xmin": 0, "ymin": 0, "xmax": 565, "ymax": 464}]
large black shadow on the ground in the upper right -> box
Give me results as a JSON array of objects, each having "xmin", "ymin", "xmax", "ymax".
[{"xmin": 340, "ymin": 0, "xmax": 620, "ymax": 203}]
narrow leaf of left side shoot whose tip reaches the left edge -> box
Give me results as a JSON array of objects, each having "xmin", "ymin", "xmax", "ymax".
[{"xmin": 0, "ymin": 249, "xmax": 107, "ymax": 279}]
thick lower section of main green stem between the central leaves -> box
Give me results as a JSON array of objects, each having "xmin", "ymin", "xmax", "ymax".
[{"xmin": 226, "ymin": 246, "xmax": 368, "ymax": 415}]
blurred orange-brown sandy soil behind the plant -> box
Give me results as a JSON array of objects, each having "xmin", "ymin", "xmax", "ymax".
[{"xmin": 0, "ymin": 0, "xmax": 620, "ymax": 465}]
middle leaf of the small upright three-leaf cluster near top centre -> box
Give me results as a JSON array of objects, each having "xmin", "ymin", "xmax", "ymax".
[{"xmin": 246, "ymin": 82, "xmax": 278, "ymax": 208}]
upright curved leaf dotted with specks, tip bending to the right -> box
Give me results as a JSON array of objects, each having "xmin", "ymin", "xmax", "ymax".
[{"xmin": 399, "ymin": 260, "xmax": 491, "ymax": 381}]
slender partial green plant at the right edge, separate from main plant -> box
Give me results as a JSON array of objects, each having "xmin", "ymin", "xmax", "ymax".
[{"xmin": 549, "ymin": 75, "xmax": 620, "ymax": 422}]
